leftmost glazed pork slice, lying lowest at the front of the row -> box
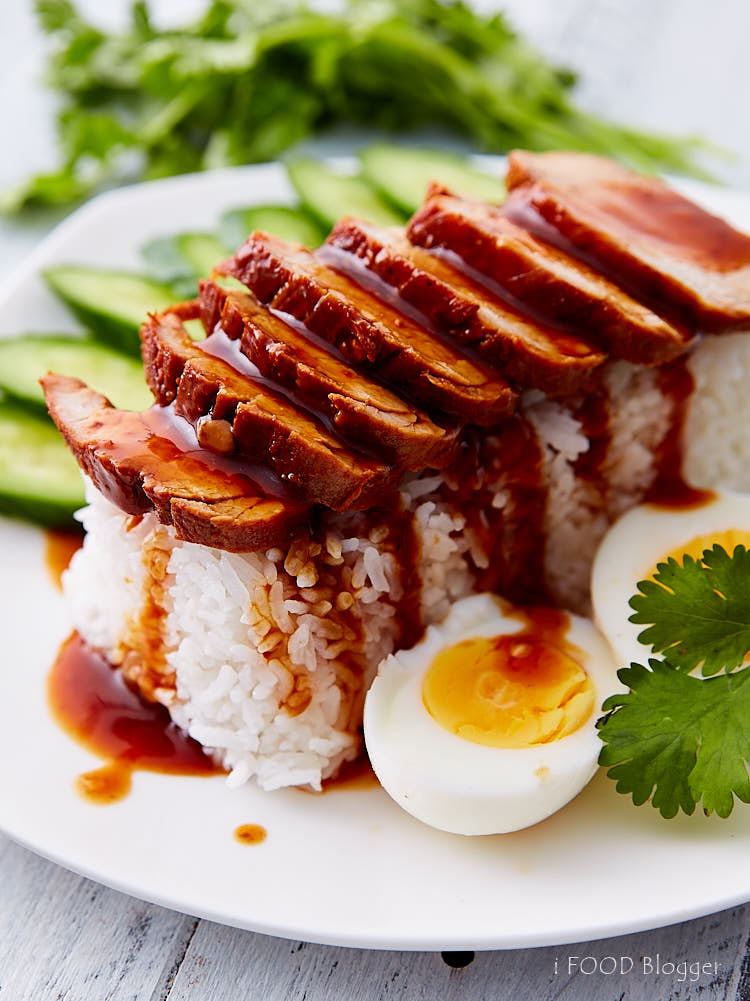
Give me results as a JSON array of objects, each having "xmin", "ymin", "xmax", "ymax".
[{"xmin": 41, "ymin": 375, "xmax": 309, "ymax": 553}]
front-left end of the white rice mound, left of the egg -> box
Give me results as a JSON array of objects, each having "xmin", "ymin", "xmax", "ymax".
[{"xmin": 64, "ymin": 486, "xmax": 401, "ymax": 789}]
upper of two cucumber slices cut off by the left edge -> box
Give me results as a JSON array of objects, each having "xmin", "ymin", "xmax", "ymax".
[{"xmin": 0, "ymin": 333, "xmax": 153, "ymax": 412}]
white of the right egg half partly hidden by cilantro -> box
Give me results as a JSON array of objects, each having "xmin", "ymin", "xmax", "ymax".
[{"xmin": 591, "ymin": 490, "xmax": 750, "ymax": 667}]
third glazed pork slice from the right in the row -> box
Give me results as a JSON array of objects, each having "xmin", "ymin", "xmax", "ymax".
[{"xmin": 318, "ymin": 217, "xmax": 605, "ymax": 395}]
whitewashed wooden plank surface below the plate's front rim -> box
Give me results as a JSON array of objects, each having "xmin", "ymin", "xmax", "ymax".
[{"xmin": 0, "ymin": 838, "xmax": 750, "ymax": 1001}]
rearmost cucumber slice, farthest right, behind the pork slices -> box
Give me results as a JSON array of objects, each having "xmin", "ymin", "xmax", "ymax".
[{"xmin": 359, "ymin": 142, "xmax": 507, "ymax": 215}]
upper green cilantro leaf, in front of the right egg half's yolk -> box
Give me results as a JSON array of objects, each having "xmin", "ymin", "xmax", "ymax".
[{"xmin": 630, "ymin": 546, "xmax": 750, "ymax": 676}]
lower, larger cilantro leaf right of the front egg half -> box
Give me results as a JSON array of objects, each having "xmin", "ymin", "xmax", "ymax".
[{"xmin": 598, "ymin": 660, "xmax": 750, "ymax": 818}]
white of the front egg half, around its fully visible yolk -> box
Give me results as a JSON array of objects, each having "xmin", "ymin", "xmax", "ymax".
[{"xmin": 364, "ymin": 595, "xmax": 623, "ymax": 835}]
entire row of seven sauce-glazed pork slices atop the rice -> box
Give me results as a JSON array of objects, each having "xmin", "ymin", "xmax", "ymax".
[{"xmin": 43, "ymin": 154, "xmax": 750, "ymax": 564}]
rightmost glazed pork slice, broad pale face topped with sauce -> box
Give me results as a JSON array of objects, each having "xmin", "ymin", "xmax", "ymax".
[{"xmin": 508, "ymin": 152, "xmax": 750, "ymax": 332}]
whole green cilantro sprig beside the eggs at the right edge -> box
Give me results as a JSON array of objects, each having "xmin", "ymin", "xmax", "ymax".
[{"xmin": 598, "ymin": 546, "xmax": 750, "ymax": 818}]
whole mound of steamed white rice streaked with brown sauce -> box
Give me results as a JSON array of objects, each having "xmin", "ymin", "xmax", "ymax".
[{"xmin": 64, "ymin": 333, "xmax": 750, "ymax": 790}]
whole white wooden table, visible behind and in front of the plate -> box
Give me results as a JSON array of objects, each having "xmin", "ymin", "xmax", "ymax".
[{"xmin": 0, "ymin": 0, "xmax": 750, "ymax": 1001}]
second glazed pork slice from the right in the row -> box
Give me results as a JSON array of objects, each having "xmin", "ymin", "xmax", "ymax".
[{"xmin": 407, "ymin": 185, "xmax": 688, "ymax": 364}]
